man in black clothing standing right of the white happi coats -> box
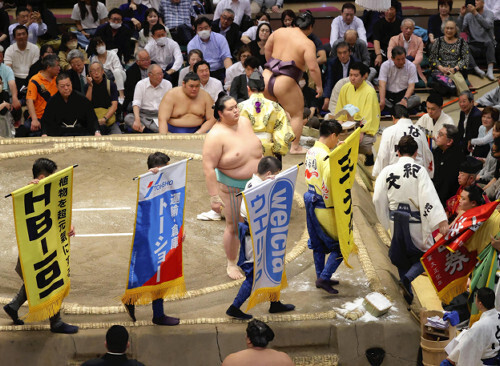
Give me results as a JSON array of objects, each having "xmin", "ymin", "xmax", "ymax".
[{"xmin": 432, "ymin": 124, "xmax": 465, "ymax": 206}]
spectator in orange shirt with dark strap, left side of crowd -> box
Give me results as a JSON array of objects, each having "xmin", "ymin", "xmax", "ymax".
[{"xmin": 22, "ymin": 55, "xmax": 61, "ymax": 137}]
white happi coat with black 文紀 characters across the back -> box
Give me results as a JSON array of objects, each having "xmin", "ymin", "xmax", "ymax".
[{"xmin": 373, "ymin": 156, "xmax": 447, "ymax": 252}]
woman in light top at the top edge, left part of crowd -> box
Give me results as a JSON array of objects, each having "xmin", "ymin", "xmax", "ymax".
[{"xmin": 71, "ymin": 0, "xmax": 108, "ymax": 47}]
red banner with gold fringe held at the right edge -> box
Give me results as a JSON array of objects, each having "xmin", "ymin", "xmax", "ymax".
[{"xmin": 421, "ymin": 201, "xmax": 498, "ymax": 304}]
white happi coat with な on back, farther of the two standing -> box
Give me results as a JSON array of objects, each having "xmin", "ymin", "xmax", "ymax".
[{"xmin": 372, "ymin": 118, "xmax": 434, "ymax": 178}]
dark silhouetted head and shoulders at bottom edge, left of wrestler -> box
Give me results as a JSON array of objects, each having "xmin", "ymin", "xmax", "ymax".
[{"xmin": 82, "ymin": 325, "xmax": 144, "ymax": 366}]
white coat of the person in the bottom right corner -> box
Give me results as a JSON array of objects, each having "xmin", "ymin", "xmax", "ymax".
[{"xmin": 446, "ymin": 308, "xmax": 500, "ymax": 366}]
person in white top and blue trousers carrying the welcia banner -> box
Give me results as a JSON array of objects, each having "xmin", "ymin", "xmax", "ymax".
[{"xmin": 226, "ymin": 156, "xmax": 295, "ymax": 319}]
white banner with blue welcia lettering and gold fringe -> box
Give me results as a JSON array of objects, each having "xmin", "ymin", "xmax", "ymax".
[{"xmin": 242, "ymin": 165, "xmax": 298, "ymax": 310}]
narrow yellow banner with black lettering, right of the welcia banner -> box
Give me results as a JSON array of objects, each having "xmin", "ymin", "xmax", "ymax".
[{"xmin": 329, "ymin": 128, "xmax": 361, "ymax": 268}]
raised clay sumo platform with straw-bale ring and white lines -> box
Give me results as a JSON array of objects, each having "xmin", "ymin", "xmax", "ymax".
[{"xmin": 0, "ymin": 135, "xmax": 420, "ymax": 366}]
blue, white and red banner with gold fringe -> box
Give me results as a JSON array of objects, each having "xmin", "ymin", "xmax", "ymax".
[{"xmin": 122, "ymin": 160, "xmax": 187, "ymax": 303}]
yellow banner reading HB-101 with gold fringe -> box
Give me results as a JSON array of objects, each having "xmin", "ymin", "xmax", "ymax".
[{"xmin": 11, "ymin": 167, "xmax": 73, "ymax": 322}]
